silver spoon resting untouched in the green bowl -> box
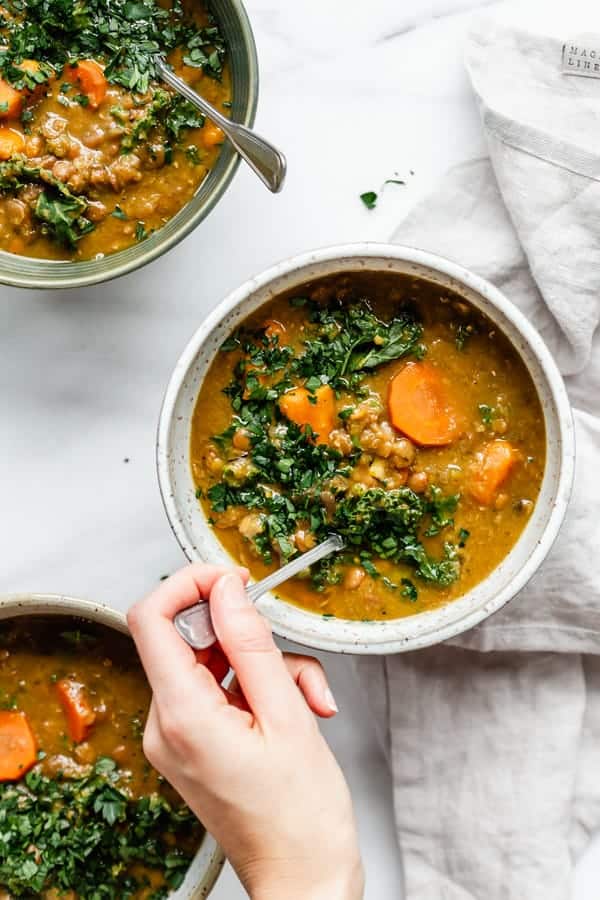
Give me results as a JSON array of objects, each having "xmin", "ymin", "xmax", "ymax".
[{"xmin": 154, "ymin": 56, "xmax": 287, "ymax": 194}]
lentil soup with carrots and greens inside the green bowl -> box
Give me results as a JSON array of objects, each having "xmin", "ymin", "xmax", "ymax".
[{"xmin": 0, "ymin": 0, "xmax": 231, "ymax": 260}]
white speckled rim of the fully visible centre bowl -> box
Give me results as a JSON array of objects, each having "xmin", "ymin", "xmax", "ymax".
[{"xmin": 156, "ymin": 242, "xmax": 575, "ymax": 655}]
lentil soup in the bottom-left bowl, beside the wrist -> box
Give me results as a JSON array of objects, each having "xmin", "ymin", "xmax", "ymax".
[{"xmin": 0, "ymin": 616, "xmax": 202, "ymax": 900}]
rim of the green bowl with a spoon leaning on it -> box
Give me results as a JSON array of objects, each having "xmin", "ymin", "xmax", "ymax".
[{"xmin": 0, "ymin": 0, "xmax": 259, "ymax": 290}]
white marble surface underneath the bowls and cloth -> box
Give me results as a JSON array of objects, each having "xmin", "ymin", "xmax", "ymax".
[{"xmin": 0, "ymin": 0, "xmax": 600, "ymax": 900}]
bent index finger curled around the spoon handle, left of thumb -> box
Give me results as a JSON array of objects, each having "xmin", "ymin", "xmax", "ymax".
[{"xmin": 127, "ymin": 563, "xmax": 247, "ymax": 703}]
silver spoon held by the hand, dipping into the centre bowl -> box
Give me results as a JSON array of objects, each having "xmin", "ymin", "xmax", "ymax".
[{"xmin": 173, "ymin": 534, "xmax": 344, "ymax": 650}]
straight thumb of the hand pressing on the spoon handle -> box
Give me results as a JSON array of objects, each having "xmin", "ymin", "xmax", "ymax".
[{"xmin": 210, "ymin": 572, "xmax": 307, "ymax": 724}]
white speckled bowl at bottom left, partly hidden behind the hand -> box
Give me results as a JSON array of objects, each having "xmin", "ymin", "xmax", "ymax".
[{"xmin": 0, "ymin": 594, "xmax": 225, "ymax": 900}]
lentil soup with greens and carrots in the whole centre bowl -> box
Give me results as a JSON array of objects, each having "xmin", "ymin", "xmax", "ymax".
[{"xmin": 190, "ymin": 272, "xmax": 546, "ymax": 620}]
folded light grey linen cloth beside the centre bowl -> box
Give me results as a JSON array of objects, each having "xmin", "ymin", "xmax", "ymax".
[{"xmin": 357, "ymin": 2, "xmax": 600, "ymax": 900}]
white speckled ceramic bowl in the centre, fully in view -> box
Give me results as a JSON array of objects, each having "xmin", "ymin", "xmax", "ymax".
[{"xmin": 157, "ymin": 244, "xmax": 575, "ymax": 654}]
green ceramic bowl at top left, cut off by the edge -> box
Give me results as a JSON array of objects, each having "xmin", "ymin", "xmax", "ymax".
[{"xmin": 0, "ymin": 0, "xmax": 258, "ymax": 288}]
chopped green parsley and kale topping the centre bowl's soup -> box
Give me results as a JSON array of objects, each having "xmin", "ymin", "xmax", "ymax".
[{"xmin": 205, "ymin": 298, "xmax": 460, "ymax": 601}]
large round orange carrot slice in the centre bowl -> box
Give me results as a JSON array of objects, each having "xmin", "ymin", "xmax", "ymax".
[{"xmin": 388, "ymin": 362, "xmax": 462, "ymax": 447}]
